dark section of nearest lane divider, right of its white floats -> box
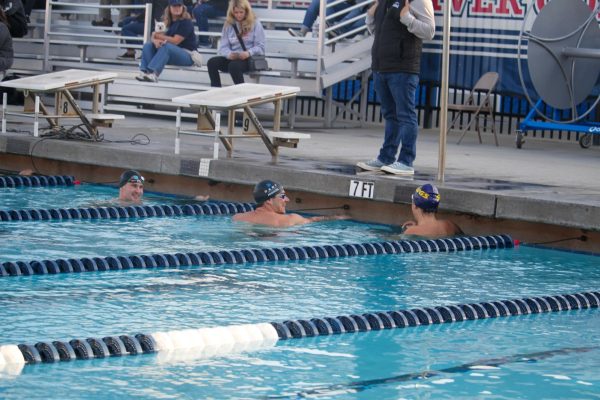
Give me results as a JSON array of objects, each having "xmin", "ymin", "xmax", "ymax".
[{"xmin": 271, "ymin": 292, "xmax": 600, "ymax": 339}]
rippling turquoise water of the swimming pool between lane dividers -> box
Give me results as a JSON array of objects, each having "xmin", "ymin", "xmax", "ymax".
[{"xmin": 0, "ymin": 183, "xmax": 600, "ymax": 398}]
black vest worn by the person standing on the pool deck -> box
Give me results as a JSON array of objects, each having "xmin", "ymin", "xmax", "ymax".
[{"xmin": 371, "ymin": 0, "xmax": 423, "ymax": 74}]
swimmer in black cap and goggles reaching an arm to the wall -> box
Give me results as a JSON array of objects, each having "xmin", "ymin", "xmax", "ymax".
[{"xmin": 233, "ymin": 180, "xmax": 348, "ymax": 228}]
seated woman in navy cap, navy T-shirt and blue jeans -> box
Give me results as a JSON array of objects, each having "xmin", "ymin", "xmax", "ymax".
[{"xmin": 135, "ymin": 0, "xmax": 196, "ymax": 82}]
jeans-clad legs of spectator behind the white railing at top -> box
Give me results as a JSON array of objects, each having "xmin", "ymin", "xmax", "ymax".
[{"xmin": 288, "ymin": 0, "xmax": 365, "ymax": 38}]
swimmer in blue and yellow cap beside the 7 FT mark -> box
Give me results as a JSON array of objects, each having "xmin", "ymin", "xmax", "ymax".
[{"xmin": 402, "ymin": 183, "xmax": 463, "ymax": 239}]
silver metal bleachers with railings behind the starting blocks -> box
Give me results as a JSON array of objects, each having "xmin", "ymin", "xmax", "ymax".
[{"xmin": 12, "ymin": 0, "xmax": 373, "ymax": 125}]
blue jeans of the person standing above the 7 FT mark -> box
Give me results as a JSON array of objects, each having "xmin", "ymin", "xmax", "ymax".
[{"xmin": 373, "ymin": 72, "xmax": 419, "ymax": 167}]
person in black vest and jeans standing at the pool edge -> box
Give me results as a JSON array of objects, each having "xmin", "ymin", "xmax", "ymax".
[{"xmin": 356, "ymin": 0, "xmax": 435, "ymax": 175}]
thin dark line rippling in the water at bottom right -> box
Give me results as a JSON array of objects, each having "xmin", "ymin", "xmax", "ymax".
[{"xmin": 264, "ymin": 346, "xmax": 599, "ymax": 399}]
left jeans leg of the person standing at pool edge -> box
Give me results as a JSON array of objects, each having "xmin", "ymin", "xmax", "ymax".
[{"xmin": 373, "ymin": 72, "xmax": 401, "ymax": 164}]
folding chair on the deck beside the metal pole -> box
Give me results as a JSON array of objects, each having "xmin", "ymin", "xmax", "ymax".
[{"xmin": 448, "ymin": 72, "xmax": 498, "ymax": 146}]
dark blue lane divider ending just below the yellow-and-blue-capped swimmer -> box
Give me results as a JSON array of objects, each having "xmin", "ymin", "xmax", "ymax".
[{"xmin": 0, "ymin": 233, "xmax": 513, "ymax": 277}]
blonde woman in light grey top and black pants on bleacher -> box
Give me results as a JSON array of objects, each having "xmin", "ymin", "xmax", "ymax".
[{"xmin": 207, "ymin": 0, "xmax": 265, "ymax": 87}]
